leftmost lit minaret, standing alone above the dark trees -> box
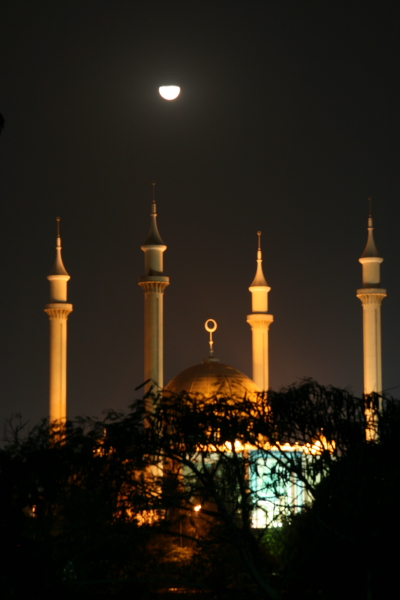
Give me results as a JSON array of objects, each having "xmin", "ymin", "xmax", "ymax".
[{"xmin": 44, "ymin": 217, "xmax": 73, "ymax": 423}]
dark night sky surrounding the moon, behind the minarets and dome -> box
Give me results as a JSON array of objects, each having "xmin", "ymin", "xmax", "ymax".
[{"xmin": 0, "ymin": 0, "xmax": 400, "ymax": 427}]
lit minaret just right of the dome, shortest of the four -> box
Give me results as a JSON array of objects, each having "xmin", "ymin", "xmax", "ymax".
[{"xmin": 247, "ymin": 231, "xmax": 274, "ymax": 391}]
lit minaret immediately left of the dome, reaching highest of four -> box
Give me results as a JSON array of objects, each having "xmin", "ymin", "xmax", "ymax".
[{"xmin": 139, "ymin": 183, "xmax": 169, "ymax": 391}]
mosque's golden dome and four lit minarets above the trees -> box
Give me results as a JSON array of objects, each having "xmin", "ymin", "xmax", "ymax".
[{"xmin": 45, "ymin": 195, "xmax": 386, "ymax": 422}]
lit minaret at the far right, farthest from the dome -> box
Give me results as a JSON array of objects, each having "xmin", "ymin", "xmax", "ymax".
[{"xmin": 357, "ymin": 204, "xmax": 386, "ymax": 394}]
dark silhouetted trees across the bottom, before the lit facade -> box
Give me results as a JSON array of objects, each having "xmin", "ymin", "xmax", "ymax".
[{"xmin": 0, "ymin": 381, "xmax": 400, "ymax": 598}]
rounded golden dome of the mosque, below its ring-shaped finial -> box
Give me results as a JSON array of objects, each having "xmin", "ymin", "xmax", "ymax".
[{"xmin": 165, "ymin": 358, "xmax": 260, "ymax": 398}]
